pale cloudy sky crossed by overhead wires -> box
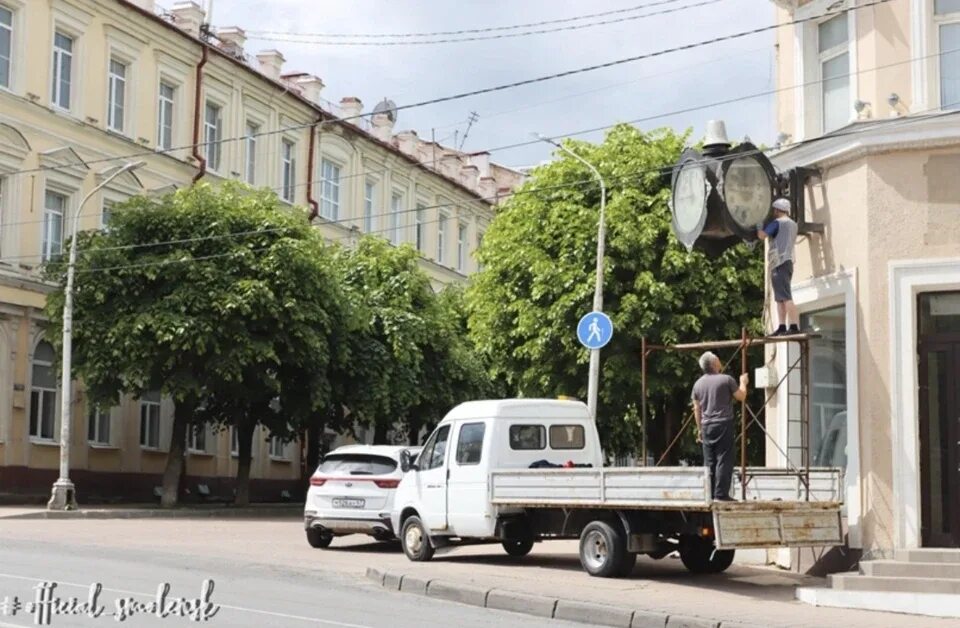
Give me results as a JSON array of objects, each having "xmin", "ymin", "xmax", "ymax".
[{"xmin": 158, "ymin": 0, "xmax": 776, "ymax": 166}]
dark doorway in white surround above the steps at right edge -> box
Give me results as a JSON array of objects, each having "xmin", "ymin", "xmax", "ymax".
[{"xmin": 917, "ymin": 292, "xmax": 960, "ymax": 547}]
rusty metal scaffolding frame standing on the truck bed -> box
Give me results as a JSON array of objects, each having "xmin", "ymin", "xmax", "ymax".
[{"xmin": 640, "ymin": 327, "xmax": 820, "ymax": 501}]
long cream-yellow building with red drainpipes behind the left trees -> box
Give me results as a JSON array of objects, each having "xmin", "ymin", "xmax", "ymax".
[{"xmin": 0, "ymin": 0, "xmax": 522, "ymax": 501}]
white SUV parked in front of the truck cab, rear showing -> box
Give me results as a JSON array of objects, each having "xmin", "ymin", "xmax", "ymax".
[{"xmin": 303, "ymin": 445, "xmax": 420, "ymax": 547}]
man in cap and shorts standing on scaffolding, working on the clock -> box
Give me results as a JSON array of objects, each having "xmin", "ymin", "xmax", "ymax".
[{"xmin": 757, "ymin": 198, "xmax": 800, "ymax": 336}]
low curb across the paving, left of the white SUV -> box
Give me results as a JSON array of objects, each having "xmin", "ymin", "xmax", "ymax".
[{"xmin": 0, "ymin": 504, "xmax": 303, "ymax": 520}]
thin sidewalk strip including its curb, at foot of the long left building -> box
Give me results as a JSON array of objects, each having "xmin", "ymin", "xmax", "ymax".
[{"xmin": 0, "ymin": 504, "xmax": 303, "ymax": 519}]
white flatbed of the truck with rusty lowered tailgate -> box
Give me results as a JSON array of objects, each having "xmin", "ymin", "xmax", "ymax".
[{"xmin": 489, "ymin": 467, "xmax": 843, "ymax": 548}]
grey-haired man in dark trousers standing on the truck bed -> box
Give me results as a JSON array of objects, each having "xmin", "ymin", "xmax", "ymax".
[{"xmin": 691, "ymin": 351, "xmax": 750, "ymax": 501}]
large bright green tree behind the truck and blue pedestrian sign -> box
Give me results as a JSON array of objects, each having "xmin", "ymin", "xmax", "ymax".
[{"xmin": 467, "ymin": 125, "xmax": 763, "ymax": 464}]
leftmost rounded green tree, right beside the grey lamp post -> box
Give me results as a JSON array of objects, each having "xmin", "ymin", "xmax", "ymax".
[{"xmin": 47, "ymin": 183, "xmax": 344, "ymax": 505}]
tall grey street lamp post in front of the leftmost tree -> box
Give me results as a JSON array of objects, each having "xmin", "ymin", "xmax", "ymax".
[{"xmin": 47, "ymin": 161, "xmax": 146, "ymax": 510}]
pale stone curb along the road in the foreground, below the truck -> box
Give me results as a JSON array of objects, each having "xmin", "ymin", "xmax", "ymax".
[{"xmin": 366, "ymin": 567, "xmax": 760, "ymax": 628}]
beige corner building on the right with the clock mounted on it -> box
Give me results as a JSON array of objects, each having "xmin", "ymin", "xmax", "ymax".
[{"xmin": 767, "ymin": 0, "xmax": 960, "ymax": 613}]
